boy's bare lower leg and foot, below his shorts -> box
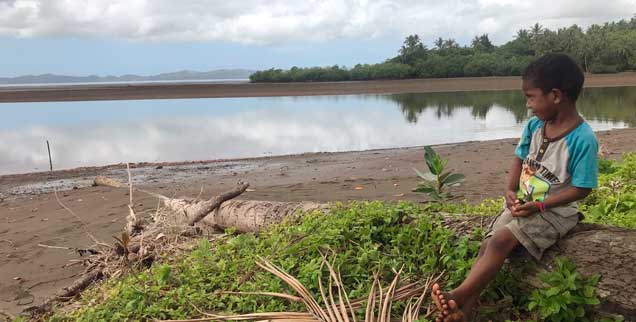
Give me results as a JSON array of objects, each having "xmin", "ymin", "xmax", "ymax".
[{"xmin": 433, "ymin": 227, "xmax": 519, "ymax": 321}]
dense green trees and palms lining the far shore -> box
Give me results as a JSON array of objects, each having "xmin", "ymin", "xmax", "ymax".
[{"xmin": 250, "ymin": 18, "xmax": 636, "ymax": 82}]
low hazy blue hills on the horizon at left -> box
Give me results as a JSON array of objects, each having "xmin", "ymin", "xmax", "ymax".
[{"xmin": 0, "ymin": 69, "xmax": 254, "ymax": 85}]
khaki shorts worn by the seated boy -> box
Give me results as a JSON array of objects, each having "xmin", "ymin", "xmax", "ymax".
[{"xmin": 486, "ymin": 208, "xmax": 581, "ymax": 260}]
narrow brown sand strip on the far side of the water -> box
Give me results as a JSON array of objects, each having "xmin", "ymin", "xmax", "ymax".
[{"xmin": 0, "ymin": 72, "xmax": 636, "ymax": 103}]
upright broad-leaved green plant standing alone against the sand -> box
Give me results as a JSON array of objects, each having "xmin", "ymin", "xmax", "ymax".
[{"xmin": 413, "ymin": 146, "xmax": 465, "ymax": 201}]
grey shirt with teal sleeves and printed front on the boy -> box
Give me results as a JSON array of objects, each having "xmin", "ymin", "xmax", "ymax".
[{"xmin": 515, "ymin": 116, "xmax": 598, "ymax": 216}]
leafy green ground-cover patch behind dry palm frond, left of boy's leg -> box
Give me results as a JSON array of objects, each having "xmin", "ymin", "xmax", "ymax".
[{"xmin": 50, "ymin": 202, "xmax": 496, "ymax": 321}]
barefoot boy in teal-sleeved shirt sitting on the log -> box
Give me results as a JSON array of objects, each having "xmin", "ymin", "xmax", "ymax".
[{"xmin": 431, "ymin": 54, "xmax": 598, "ymax": 322}]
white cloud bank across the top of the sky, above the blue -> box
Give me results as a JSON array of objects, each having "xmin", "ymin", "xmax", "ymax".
[{"xmin": 0, "ymin": 0, "xmax": 636, "ymax": 45}]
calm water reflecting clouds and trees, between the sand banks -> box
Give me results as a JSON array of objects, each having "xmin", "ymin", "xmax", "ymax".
[{"xmin": 0, "ymin": 87, "xmax": 636, "ymax": 174}]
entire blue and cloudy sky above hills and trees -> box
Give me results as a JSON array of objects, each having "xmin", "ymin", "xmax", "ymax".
[{"xmin": 0, "ymin": 0, "xmax": 636, "ymax": 77}]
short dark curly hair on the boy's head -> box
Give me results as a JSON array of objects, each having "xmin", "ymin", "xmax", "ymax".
[{"xmin": 521, "ymin": 54, "xmax": 585, "ymax": 102}]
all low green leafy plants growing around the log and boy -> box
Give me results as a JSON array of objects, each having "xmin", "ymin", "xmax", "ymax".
[{"xmin": 39, "ymin": 154, "xmax": 636, "ymax": 321}]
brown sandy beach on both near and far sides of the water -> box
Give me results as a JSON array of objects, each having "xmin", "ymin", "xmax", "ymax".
[{"xmin": 0, "ymin": 73, "xmax": 636, "ymax": 320}]
